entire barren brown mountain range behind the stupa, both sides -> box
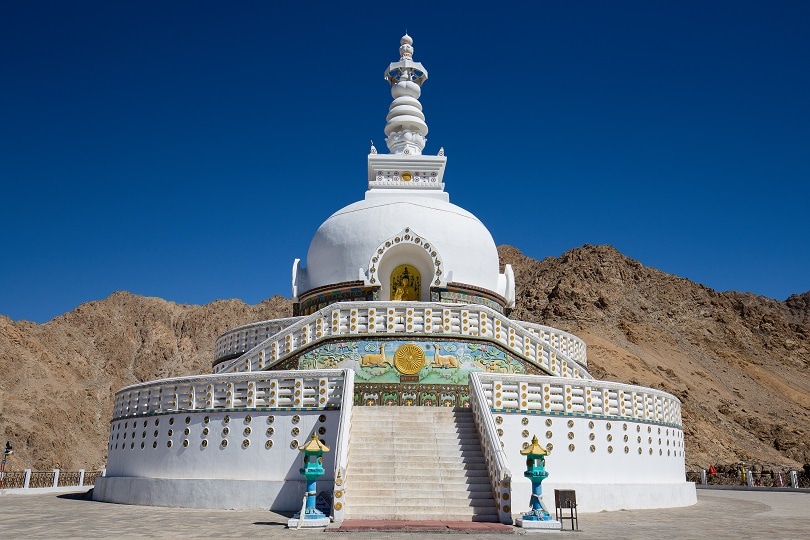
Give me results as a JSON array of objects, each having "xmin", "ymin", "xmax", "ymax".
[{"xmin": 0, "ymin": 246, "xmax": 810, "ymax": 470}]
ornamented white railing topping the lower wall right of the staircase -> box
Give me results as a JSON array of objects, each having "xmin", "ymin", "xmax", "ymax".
[{"xmin": 471, "ymin": 373, "xmax": 682, "ymax": 428}]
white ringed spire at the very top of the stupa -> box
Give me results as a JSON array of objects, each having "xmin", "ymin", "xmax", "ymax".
[{"xmin": 385, "ymin": 34, "xmax": 428, "ymax": 155}]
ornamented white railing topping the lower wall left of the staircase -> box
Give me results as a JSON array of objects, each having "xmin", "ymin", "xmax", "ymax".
[{"xmin": 113, "ymin": 369, "xmax": 345, "ymax": 422}]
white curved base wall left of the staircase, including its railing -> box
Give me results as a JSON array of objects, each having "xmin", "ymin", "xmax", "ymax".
[{"xmin": 93, "ymin": 370, "xmax": 351, "ymax": 510}]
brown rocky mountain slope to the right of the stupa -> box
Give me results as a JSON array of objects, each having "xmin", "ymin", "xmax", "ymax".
[{"xmin": 499, "ymin": 246, "xmax": 810, "ymax": 469}]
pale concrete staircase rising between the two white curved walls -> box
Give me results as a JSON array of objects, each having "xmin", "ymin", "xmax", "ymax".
[{"xmin": 345, "ymin": 406, "xmax": 498, "ymax": 522}]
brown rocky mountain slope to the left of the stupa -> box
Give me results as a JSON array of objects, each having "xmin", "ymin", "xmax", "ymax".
[{"xmin": 0, "ymin": 292, "xmax": 292, "ymax": 470}]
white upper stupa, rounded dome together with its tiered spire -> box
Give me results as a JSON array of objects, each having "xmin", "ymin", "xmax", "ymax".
[{"xmin": 293, "ymin": 34, "xmax": 515, "ymax": 313}]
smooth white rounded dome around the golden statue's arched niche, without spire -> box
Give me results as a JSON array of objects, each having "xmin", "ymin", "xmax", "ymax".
[{"xmin": 302, "ymin": 191, "xmax": 504, "ymax": 299}]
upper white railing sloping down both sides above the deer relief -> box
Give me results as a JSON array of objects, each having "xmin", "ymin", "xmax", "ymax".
[{"xmin": 214, "ymin": 302, "xmax": 593, "ymax": 379}]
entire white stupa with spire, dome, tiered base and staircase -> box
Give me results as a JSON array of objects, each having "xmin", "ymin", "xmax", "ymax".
[{"xmin": 94, "ymin": 35, "xmax": 696, "ymax": 523}]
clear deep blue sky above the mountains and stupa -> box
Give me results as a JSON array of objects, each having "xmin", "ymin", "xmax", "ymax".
[{"xmin": 0, "ymin": 0, "xmax": 810, "ymax": 322}]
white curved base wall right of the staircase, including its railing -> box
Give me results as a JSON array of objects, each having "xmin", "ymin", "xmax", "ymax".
[{"xmin": 471, "ymin": 373, "xmax": 697, "ymax": 514}]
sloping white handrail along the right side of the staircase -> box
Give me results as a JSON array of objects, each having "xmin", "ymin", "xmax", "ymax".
[{"xmin": 470, "ymin": 372, "xmax": 512, "ymax": 525}]
